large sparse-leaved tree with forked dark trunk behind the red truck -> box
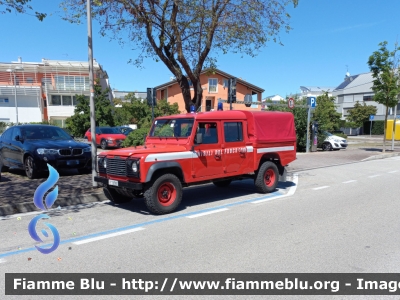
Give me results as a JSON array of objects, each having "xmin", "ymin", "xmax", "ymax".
[{"xmin": 61, "ymin": 0, "xmax": 298, "ymax": 112}]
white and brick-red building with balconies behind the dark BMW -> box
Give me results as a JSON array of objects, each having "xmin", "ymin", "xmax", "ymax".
[{"xmin": 0, "ymin": 58, "xmax": 111, "ymax": 127}]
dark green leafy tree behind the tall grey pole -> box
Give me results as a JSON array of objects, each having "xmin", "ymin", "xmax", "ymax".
[{"xmin": 66, "ymin": 79, "xmax": 115, "ymax": 137}]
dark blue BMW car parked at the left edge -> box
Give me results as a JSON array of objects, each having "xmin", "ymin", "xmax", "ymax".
[{"xmin": 0, "ymin": 125, "xmax": 91, "ymax": 179}]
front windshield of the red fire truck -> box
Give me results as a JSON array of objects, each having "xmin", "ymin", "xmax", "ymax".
[{"xmin": 150, "ymin": 119, "xmax": 194, "ymax": 138}]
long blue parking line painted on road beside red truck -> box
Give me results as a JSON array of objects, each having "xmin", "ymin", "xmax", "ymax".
[{"xmin": 0, "ymin": 192, "xmax": 284, "ymax": 259}]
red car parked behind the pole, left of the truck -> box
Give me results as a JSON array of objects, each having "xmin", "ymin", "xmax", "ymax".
[{"xmin": 85, "ymin": 127, "xmax": 126, "ymax": 150}]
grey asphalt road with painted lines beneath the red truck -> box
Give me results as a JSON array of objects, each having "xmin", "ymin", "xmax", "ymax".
[{"xmin": 0, "ymin": 157, "xmax": 400, "ymax": 299}]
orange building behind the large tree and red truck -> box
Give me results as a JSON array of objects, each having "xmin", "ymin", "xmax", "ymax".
[{"xmin": 155, "ymin": 70, "xmax": 264, "ymax": 113}]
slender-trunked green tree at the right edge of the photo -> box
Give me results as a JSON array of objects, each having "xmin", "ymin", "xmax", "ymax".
[{"xmin": 368, "ymin": 41, "xmax": 400, "ymax": 152}]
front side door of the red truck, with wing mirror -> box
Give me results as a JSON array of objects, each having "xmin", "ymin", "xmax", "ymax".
[{"xmin": 192, "ymin": 122, "xmax": 223, "ymax": 179}]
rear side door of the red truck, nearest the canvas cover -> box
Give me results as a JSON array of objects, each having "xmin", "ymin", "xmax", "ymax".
[{"xmin": 222, "ymin": 121, "xmax": 248, "ymax": 173}]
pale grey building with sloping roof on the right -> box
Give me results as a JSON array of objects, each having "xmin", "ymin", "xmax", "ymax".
[{"xmin": 332, "ymin": 72, "xmax": 400, "ymax": 120}]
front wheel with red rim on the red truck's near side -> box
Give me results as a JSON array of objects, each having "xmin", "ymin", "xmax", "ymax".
[{"xmin": 144, "ymin": 174, "xmax": 182, "ymax": 215}]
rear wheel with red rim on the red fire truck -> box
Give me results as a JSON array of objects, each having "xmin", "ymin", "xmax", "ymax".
[{"xmin": 255, "ymin": 161, "xmax": 279, "ymax": 193}]
